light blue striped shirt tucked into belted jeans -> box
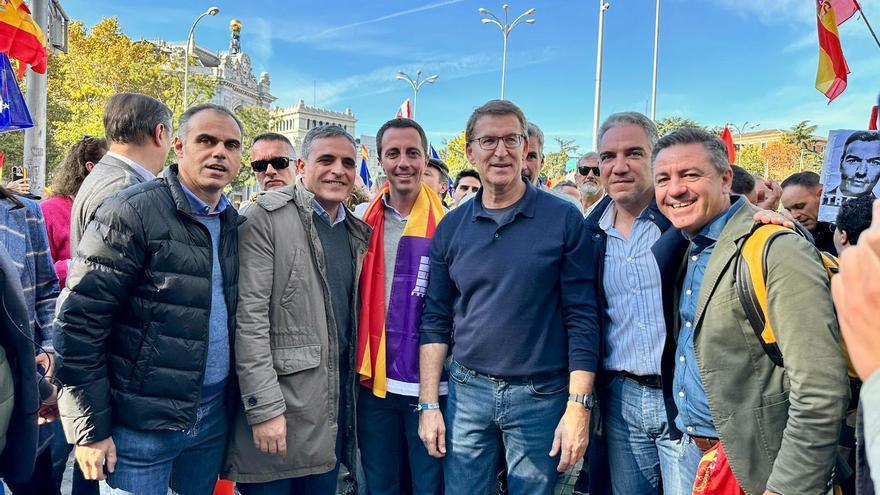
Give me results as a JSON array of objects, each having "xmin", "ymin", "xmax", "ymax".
[{"xmin": 599, "ymin": 201, "xmax": 666, "ymax": 376}]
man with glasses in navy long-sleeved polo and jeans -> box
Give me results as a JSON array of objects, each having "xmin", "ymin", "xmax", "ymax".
[{"xmin": 417, "ymin": 100, "xmax": 599, "ymax": 495}]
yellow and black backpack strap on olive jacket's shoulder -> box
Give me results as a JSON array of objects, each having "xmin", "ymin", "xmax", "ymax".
[{"xmin": 734, "ymin": 225, "xmax": 797, "ymax": 366}]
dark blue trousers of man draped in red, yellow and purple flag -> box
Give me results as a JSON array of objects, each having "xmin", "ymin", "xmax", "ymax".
[{"xmin": 357, "ymin": 388, "xmax": 446, "ymax": 495}]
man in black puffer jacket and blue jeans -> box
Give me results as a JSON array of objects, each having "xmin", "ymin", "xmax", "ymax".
[{"xmin": 55, "ymin": 105, "xmax": 244, "ymax": 495}]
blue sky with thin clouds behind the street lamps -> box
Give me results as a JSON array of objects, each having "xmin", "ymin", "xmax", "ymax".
[{"xmin": 63, "ymin": 0, "xmax": 880, "ymax": 151}]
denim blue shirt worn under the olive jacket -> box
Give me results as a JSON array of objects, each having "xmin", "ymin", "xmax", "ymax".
[{"xmin": 672, "ymin": 197, "xmax": 744, "ymax": 438}]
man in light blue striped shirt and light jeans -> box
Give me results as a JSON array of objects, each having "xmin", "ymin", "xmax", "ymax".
[{"xmin": 583, "ymin": 112, "xmax": 678, "ymax": 494}]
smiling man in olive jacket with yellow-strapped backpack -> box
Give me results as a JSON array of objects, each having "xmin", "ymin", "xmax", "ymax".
[{"xmin": 653, "ymin": 129, "xmax": 849, "ymax": 495}]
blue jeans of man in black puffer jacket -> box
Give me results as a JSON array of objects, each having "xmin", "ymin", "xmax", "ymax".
[{"xmin": 100, "ymin": 393, "xmax": 228, "ymax": 495}]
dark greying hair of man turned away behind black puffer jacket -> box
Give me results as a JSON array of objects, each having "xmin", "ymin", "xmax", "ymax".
[{"xmin": 103, "ymin": 93, "xmax": 172, "ymax": 145}]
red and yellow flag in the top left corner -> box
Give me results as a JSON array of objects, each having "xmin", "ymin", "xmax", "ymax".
[{"xmin": 0, "ymin": 0, "xmax": 49, "ymax": 77}]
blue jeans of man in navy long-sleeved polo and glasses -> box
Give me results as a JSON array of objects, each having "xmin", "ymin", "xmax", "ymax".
[{"xmin": 443, "ymin": 360, "xmax": 568, "ymax": 495}]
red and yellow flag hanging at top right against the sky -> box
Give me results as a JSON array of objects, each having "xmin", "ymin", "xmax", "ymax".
[{"xmin": 816, "ymin": 0, "xmax": 849, "ymax": 103}]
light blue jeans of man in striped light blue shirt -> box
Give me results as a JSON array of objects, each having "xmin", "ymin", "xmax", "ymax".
[{"xmin": 602, "ymin": 376, "xmax": 680, "ymax": 495}]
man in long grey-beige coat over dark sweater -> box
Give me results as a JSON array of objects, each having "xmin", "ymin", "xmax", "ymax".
[{"xmin": 224, "ymin": 126, "xmax": 370, "ymax": 495}]
